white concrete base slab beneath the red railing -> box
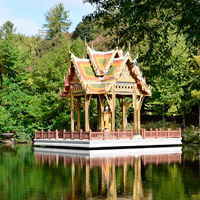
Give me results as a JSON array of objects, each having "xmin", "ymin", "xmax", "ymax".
[{"xmin": 34, "ymin": 138, "xmax": 182, "ymax": 149}]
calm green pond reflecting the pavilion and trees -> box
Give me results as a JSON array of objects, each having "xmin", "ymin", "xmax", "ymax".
[{"xmin": 0, "ymin": 145, "xmax": 200, "ymax": 200}]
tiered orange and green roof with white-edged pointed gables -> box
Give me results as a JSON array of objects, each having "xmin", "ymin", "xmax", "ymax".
[{"xmin": 61, "ymin": 45, "xmax": 151, "ymax": 97}]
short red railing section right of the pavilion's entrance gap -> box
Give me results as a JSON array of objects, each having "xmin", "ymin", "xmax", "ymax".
[{"xmin": 141, "ymin": 128, "xmax": 181, "ymax": 139}]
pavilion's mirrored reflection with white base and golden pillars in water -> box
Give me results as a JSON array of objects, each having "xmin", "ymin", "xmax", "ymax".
[{"xmin": 35, "ymin": 147, "xmax": 182, "ymax": 200}]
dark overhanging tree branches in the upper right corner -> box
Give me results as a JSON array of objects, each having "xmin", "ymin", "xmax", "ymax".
[{"xmin": 84, "ymin": 0, "xmax": 200, "ymax": 46}]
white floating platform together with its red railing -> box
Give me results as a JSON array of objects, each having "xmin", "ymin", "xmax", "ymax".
[{"xmin": 34, "ymin": 129, "xmax": 182, "ymax": 149}]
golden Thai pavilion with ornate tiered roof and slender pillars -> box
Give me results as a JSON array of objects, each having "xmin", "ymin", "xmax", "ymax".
[{"xmin": 61, "ymin": 44, "xmax": 151, "ymax": 134}]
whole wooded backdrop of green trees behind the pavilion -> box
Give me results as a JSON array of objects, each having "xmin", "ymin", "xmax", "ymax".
[{"xmin": 0, "ymin": 0, "xmax": 200, "ymax": 140}]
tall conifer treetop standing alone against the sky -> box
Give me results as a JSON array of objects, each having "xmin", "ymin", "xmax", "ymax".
[{"xmin": 44, "ymin": 3, "xmax": 71, "ymax": 39}]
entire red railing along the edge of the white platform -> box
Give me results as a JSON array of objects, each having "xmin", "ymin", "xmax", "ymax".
[{"xmin": 35, "ymin": 129, "xmax": 181, "ymax": 140}]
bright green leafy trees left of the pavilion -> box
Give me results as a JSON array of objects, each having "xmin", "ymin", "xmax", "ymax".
[{"xmin": 0, "ymin": 24, "xmax": 84, "ymax": 138}]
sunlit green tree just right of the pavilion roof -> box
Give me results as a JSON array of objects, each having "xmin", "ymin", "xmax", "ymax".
[{"xmin": 147, "ymin": 32, "xmax": 194, "ymax": 128}]
